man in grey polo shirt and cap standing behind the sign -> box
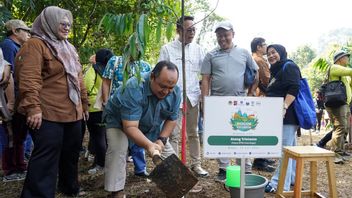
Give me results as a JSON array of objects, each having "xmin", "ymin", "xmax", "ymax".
[{"xmin": 201, "ymin": 21, "xmax": 258, "ymax": 182}]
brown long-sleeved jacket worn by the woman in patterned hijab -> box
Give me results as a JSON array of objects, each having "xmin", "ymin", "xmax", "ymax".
[{"xmin": 15, "ymin": 38, "xmax": 88, "ymax": 122}]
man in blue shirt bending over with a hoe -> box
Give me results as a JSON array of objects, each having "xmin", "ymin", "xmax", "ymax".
[{"xmin": 103, "ymin": 61, "xmax": 181, "ymax": 197}]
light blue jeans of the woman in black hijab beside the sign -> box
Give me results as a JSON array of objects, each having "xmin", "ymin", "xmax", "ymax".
[{"xmin": 270, "ymin": 124, "xmax": 298, "ymax": 191}]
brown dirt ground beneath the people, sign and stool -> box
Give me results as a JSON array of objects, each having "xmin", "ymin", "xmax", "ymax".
[{"xmin": 0, "ymin": 131, "xmax": 352, "ymax": 198}]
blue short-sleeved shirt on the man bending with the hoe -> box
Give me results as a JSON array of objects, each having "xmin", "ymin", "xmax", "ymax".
[{"xmin": 103, "ymin": 73, "xmax": 181, "ymax": 141}]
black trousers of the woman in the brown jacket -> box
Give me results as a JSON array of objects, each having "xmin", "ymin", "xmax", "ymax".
[{"xmin": 21, "ymin": 116, "xmax": 81, "ymax": 198}]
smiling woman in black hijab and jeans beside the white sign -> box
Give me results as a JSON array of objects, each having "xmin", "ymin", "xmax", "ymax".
[{"xmin": 265, "ymin": 44, "xmax": 301, "ymax": 193}]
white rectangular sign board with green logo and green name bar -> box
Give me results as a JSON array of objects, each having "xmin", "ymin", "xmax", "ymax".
[{"xmin": 203, "ymin": 96, "xmax": 283, "ymax": 158}]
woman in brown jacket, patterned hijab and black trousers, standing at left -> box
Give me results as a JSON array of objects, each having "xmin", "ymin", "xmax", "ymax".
[{"xmin": 15, "ymin": 6, "xmax": 88, "ymax": 198}]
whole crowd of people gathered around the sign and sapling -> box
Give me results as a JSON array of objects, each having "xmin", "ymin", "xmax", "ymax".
[{"xmin": 0, "ymin": 6, "xmax": 352, "ymax": 198}]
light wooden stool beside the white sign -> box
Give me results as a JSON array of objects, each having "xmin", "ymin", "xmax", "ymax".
[{"xmin": 276, "ymin": 146, "xmax": 337, "ymax": 198}]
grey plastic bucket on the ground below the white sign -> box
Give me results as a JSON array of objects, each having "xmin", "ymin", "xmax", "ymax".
[{"xmin": 230, "ymin": 174, "xmax": 268, "ymax": 198}]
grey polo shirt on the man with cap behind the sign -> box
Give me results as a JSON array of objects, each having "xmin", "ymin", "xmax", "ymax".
[{"xmin": 201, "ymin": 45, "xmax": 258, "ymax": 96}]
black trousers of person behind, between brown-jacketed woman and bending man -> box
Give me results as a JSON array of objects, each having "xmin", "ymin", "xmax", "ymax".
[{"xmin": 87, "ymin": 111, "xmax": 107, "ymax": 167}]
